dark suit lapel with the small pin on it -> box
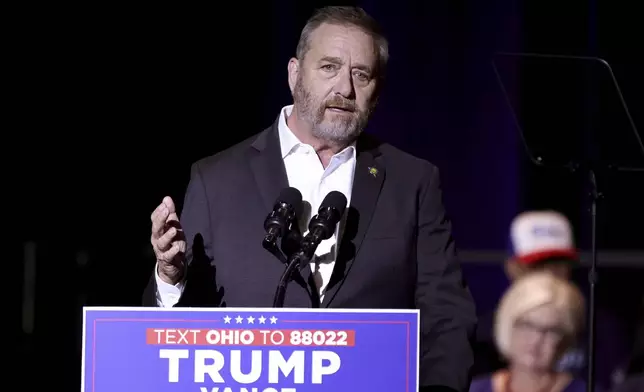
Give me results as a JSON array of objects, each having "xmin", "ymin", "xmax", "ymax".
[{"xmin": 322, "ymin": 135, "xmax": 385, "ymax": 307}]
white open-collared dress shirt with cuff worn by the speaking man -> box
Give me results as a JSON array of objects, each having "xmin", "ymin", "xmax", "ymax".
[{"xmin": 154, "ymin": 105, "xmax": 356, "ymax": 307}]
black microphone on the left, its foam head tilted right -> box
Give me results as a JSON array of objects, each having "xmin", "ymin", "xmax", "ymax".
[{"xmin": 262, "ymin": 187, "xmax": 302, "ymax": 252}]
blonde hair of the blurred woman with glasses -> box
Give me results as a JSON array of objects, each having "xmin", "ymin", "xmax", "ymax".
[{"xmin": 494, "ymin": 271, "xmax": 585, "ymax": 358}]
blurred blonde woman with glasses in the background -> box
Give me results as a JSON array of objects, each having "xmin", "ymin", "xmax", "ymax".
[{"xmin": 470, "ymin": 272, "xmax": 586, "ymax": 392}]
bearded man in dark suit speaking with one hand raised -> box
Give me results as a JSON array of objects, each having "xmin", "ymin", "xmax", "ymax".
[{"xmin": 144, "ymin": 7, "xmax": 476, "ymax": 391}]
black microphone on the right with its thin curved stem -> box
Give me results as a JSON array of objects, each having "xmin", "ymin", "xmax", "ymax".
[{"xmin": 273, "ymin": 191, "xmax": 347, "ymax": 308}]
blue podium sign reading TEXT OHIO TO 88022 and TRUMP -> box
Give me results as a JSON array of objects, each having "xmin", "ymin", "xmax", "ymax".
[{"xmin": 81, "ymin": 307, "xmax": 419, "ymax": 392}]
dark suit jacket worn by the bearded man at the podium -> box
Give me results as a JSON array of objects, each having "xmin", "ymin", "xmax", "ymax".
[{"xmin": 144, "ymin": 118, "xmax": 476, "ymax": 391}]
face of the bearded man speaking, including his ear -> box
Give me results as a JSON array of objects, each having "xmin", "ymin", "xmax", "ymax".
[{"xmin": 289, "ymin": 24, "xmax": 378, "ymax": 144}]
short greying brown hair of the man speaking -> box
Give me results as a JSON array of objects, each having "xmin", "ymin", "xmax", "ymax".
[{"xmin": 295, "ymin": 6, "xmax": 389, "ymax": 78}]
